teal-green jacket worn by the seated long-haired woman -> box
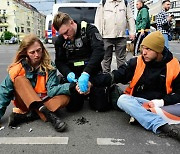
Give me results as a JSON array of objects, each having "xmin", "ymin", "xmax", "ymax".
[{"xmin": 0, "ymin": 61, "xmax": 70, "ymax": 119}]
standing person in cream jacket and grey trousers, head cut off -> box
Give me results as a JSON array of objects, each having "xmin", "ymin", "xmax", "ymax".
[{"xmin": 95, "ymin": 0, "xmax": 135, "ymax": 72}]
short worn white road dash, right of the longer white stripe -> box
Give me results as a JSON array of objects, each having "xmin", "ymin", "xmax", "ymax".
[{"xmin": 97, "ymin": 138, "xmax": 125, "ymax": 145}]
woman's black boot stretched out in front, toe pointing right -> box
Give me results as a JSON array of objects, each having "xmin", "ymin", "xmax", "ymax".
[{"xmin": 39, "ymin": 106, "xmax": 67, "ymax": 132}]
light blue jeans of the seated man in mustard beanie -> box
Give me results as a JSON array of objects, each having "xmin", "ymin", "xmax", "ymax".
[{"xmin": 117, "ymin": 94, "xmax": 167, "ymax": 133}]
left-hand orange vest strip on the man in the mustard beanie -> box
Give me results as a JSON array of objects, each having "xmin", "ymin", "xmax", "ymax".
[{"xmin": 125, "ymin": 55, "xmax": 145, "ymax": 95}]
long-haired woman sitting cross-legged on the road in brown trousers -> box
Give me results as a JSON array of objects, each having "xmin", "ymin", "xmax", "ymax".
[{"xmin": 0, "ymin": 34, "xmax": 75, "ymax": 132}]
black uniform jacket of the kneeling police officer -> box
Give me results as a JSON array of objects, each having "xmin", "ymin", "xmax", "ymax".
[{"xmin": 55, "ymin": 23, "xmax": 104, "ymax": 77}]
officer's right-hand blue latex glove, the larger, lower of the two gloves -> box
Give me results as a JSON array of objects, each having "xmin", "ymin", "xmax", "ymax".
[{"xmin": 78, "ymin": 72, "xmax": 90, "ymax": 92}]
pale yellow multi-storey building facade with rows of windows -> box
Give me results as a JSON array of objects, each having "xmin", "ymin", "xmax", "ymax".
[{"xmin": 0, "ymin": 0, "xmax": 46, "ymax": 40}]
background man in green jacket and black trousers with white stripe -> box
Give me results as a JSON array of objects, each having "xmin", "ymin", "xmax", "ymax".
[{"xmin": 134, "ymin": 0, "xmax": 150, "ymax": 56}]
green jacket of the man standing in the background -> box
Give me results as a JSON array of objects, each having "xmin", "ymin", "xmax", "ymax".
[{"xmin": 136, "ymin": 5, "xmax": 150, "ymax": 32}]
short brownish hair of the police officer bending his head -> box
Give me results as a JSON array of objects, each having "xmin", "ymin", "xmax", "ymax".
[{"xmin": 53, "ymin": 12, "xmax": 72, "ymax": 31}]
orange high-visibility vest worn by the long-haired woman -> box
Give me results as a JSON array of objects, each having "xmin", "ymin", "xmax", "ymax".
[{"xmin": 9, "ymin": 63, "xmax": 48, "ymax": 96}]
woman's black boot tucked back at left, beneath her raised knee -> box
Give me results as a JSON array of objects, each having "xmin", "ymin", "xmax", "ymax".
[{"xmin": 8, "ymin": 111, "xmax": 39, "ymax": 127}]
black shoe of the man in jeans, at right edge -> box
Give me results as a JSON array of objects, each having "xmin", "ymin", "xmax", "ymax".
[{"xmin": 160, "ymin": 124, "xmax": 180, "ymax": 141}]
